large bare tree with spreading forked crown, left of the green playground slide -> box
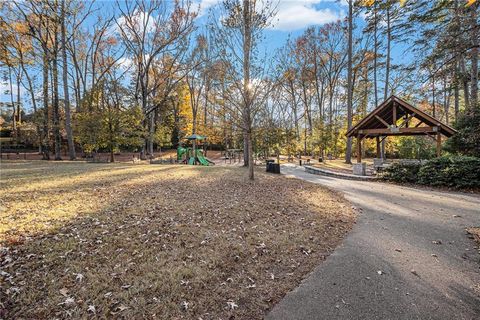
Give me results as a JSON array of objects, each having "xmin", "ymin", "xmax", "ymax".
[{"xmin": 116, "ymin": 0, "xmax": 196, "ymax": 157}]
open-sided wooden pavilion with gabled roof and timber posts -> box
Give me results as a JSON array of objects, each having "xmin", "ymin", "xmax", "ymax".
[{"xmin": 346, "ymin": 96, "xmax": 457, "ymax": 163}]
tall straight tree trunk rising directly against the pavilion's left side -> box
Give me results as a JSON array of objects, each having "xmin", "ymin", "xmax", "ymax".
[{"xmin": 345, "ymin": 0, "xmax": 353, "ymax": 163}]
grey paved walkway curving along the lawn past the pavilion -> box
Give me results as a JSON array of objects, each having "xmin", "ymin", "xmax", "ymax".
[{"xmin": 266, "ymin": 165, "xmax": 480, "ymax": 320}]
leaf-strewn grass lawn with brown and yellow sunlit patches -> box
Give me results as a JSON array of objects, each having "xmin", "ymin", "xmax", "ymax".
[{"xmin": 0, "ymin": 161, "xmax": 354, "ymax": 319}]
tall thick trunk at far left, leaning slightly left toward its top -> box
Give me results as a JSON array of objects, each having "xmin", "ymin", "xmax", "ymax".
[{"xmin": 60, "ymin": 0, "xmax": 76, "ymax": 160}]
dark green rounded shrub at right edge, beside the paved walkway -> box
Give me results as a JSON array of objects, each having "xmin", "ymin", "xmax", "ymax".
[{"xmin": 418, "ymin": 156, "xmax": 480, "ymax": 189}]
